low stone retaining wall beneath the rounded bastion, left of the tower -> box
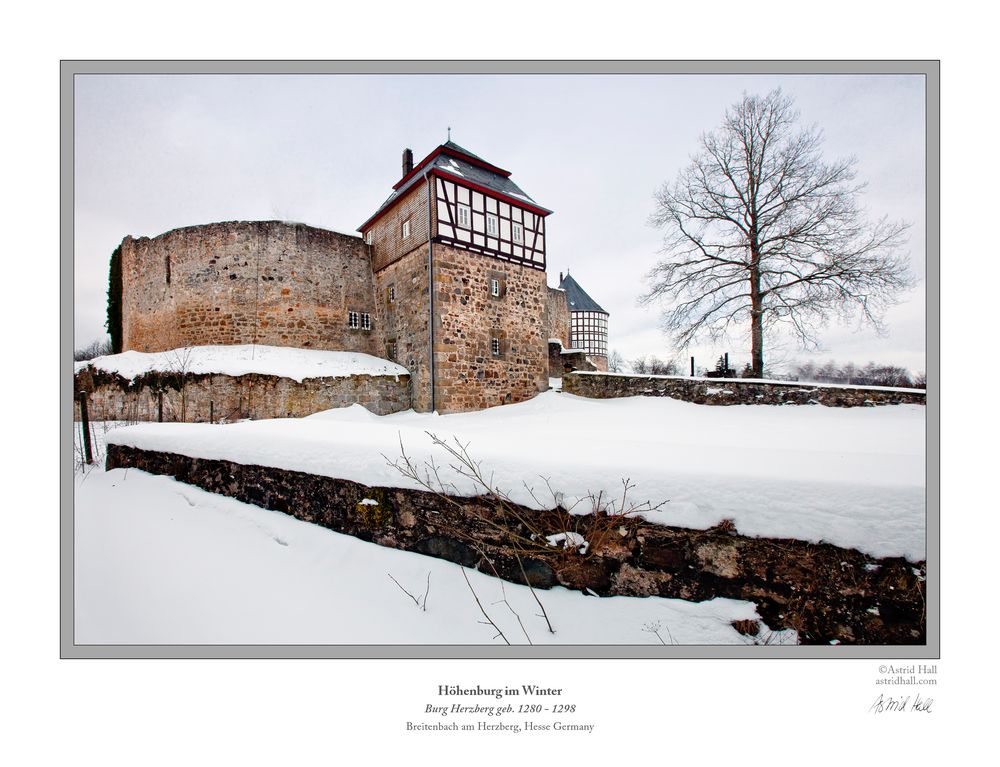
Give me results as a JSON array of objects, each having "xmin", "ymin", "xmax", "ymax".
[{"xmin": 73, "ymin": 367, "xmax": 410, "ymax": 423}]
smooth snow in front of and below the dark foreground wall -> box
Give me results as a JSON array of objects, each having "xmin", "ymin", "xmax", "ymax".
[{"xmin": 74, "ymin": 440, "xmax": 795, "ymax": 645}]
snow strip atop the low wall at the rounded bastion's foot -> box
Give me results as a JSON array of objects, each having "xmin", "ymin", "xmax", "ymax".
[{"xmin": 75, "ymin": 344, "xmax": 407, "ymax": 381}]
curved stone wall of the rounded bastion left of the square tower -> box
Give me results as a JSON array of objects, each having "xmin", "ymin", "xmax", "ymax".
[{"xmin": 121, "ymin": 221, "xmax": 384, "ymax": 356}]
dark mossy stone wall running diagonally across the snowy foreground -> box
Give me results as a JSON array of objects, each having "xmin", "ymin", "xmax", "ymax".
[{"xmin": 106, "ymin": 444, "xmax": 926, "ymax": 645}]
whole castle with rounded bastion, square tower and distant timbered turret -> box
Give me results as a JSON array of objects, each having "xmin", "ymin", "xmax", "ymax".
[{"xmin": 109, "ymin": 140, "xmax": 608, "ymax": 412}]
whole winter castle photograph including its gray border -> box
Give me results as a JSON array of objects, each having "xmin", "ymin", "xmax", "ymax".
[{"xmin": 62, "ymin": 61, "xmax": 940, "ymax": 664}]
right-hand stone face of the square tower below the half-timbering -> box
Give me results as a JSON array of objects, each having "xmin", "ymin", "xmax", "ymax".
[{"xmin": 434, "ymin": 243, "xmax": 548, "ymax": 412}]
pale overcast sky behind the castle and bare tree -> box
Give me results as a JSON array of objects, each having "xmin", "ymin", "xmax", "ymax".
[{"xmin": 75, "ymin": 75, "xmax": 926, "ymax": 371}]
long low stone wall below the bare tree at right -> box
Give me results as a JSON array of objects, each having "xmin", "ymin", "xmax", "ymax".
[{"xmin": 563, "ymin": 372, "xmax": 927, "ymax": 407}]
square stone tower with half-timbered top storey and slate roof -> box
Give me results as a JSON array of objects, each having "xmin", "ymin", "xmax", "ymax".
[{"xmin": 359, "ymin": 140, "xmax": 584, "ymax": 412}]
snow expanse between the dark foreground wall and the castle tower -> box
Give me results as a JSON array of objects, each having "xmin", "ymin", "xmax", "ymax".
[{"xmin": 109, "ymin": 391, "xmax": 926, "ymax": 561}]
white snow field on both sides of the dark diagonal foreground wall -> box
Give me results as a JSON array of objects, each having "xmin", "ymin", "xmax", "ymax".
[{"xmin": 74, "ymin": 391, "xmax": 925, "ymax": 645}]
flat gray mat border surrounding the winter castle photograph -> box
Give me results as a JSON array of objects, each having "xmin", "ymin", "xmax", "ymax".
[{"xmin": 59, "ymin": 60, "xmax": 941, "ymax": 659}]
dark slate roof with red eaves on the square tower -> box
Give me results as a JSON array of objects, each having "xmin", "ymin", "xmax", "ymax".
[{"xmin": 358, "ymin": 141, "xmax": 552, "ymax": 232}]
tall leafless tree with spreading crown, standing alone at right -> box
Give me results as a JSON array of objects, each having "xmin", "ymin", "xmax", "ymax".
[{"xmin": 641, "ymin": 90, "xmax": 912, "ymax": 377}]
